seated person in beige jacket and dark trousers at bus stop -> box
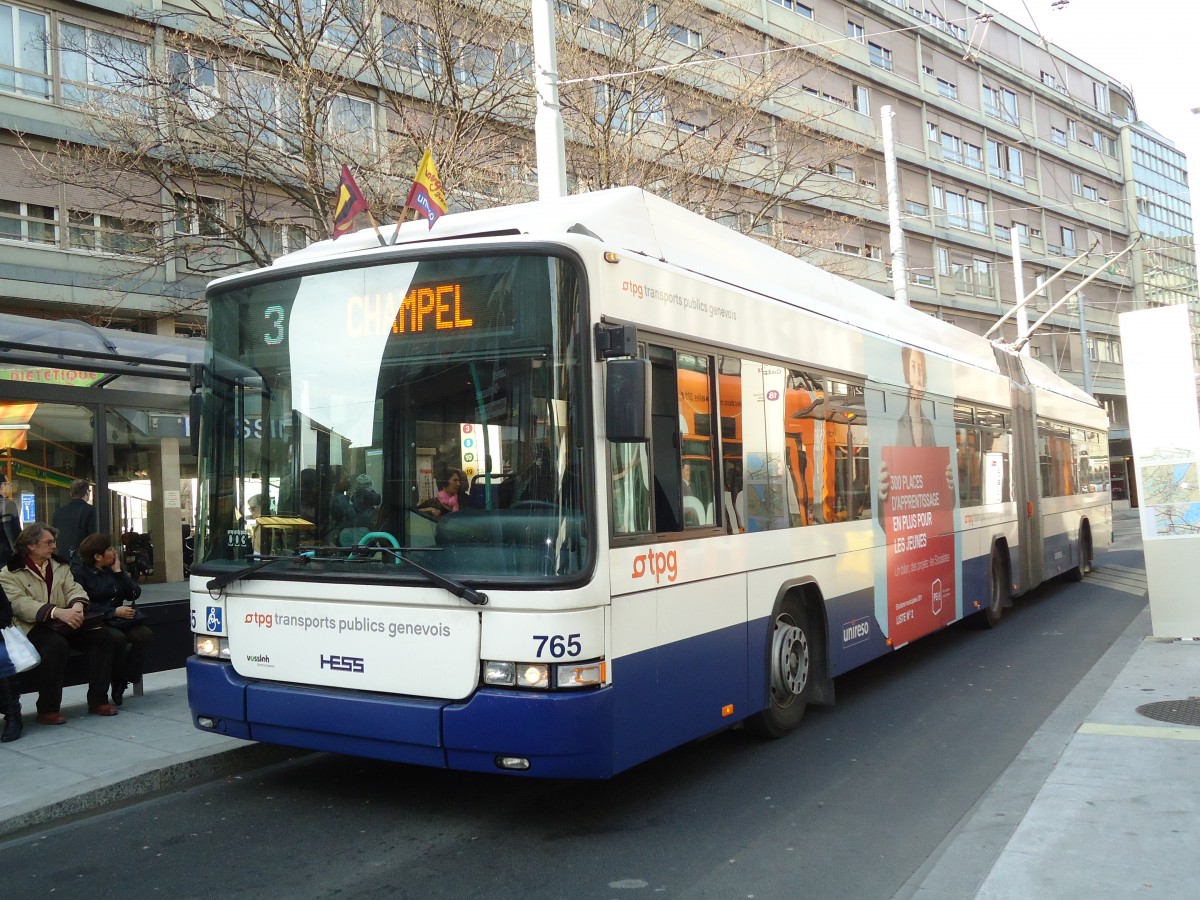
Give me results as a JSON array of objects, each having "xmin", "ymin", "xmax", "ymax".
[{"xmin": 0, "ymin": 522, "xmax": 116, "ymax": 725}]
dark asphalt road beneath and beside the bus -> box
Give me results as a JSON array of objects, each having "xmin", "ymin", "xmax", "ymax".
[{"xmin": 0, "ymin": 551, "xmax": 1145, "ymax": 900}]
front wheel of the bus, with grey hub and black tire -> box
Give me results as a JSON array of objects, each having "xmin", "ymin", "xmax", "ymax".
[{"xmin": 746, "ymin": 598, "xmax": 817, "ymax": 738}]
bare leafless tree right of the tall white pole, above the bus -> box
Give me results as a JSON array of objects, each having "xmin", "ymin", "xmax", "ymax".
[{"xmin": 549, "ymin": 0, "xmax": 864, "ymax": 253}]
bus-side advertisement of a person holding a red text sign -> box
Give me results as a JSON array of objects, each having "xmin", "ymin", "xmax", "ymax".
[{"xmin": 874, "ymin": 348, "xmax": 961, "ymax": 647}]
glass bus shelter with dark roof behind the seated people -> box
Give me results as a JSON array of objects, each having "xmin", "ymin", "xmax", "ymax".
[{"xmin": 0, "ymin": 313, "xmax": 204, "ymax": 582}]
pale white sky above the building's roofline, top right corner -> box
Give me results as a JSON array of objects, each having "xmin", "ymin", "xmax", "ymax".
[{"xmin": 984, "ymin": 0, "xmax": 1200, "ymax": 204}]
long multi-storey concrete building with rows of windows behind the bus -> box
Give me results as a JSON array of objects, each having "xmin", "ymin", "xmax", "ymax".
[{"xmin": 0, "ymin": 0, "xmax": 1198, "ymax": 554}]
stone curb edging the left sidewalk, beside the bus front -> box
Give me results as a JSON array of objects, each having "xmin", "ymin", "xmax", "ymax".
[{"xmin": 0, "ymin": 744, "xmax": 300, "ymax": 838}]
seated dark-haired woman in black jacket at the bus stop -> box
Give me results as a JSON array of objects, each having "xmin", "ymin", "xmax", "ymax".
[{"xmin": 71, "ymin": 534, "xmax": 154, "ymax": 706}]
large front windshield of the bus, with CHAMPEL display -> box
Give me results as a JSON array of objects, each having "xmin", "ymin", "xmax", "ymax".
[{"xmin": 196, "ymin": 253, "xmax": 593, "ymax": 581}]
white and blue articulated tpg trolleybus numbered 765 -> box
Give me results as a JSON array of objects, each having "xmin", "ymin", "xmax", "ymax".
[{"xmin": 187, "ymin": 188, "xmax": 1111, "ymax": 778}]
